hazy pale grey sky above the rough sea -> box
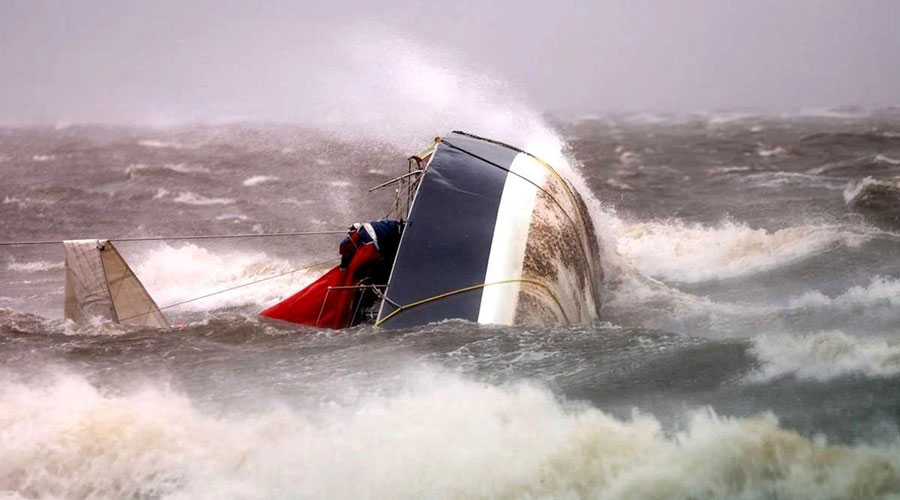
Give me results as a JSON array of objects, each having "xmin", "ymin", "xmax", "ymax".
[{"xmin": 0, "ymin": 0, "xmax": 900, "ymax": 123}]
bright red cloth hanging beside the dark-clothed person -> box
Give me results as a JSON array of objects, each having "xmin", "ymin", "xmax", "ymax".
[{"xmin": 259, "ymin": 244, "xmax": 380, "ymax": 328}]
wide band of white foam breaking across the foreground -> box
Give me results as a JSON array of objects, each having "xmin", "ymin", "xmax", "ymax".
[{"xmin": 0, "ymin": 373, "xmax": 900, "ymax": 499}]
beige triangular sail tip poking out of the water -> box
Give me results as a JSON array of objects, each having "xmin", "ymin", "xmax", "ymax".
[{"xmin": 63, "ymin": 239, "xmax": 169, "ymax": 328}]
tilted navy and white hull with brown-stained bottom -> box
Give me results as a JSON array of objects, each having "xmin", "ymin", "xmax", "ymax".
[{"xmin": 376, "ymin": 132, "xmax": 602, "ymax": 328}]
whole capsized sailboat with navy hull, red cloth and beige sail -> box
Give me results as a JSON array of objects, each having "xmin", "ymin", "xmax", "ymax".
[{"xmin": 59, "ymin": 132, "xmax": 602, "ymax": 328}]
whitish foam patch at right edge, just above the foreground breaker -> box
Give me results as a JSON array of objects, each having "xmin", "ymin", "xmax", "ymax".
[{"xmin": 750, "ymin": 331, "xmax": 900, "ymax": 381}]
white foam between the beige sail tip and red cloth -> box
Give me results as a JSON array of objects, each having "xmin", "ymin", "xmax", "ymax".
[{"xmin": 130, "ymin": 244, "xmax": 318, "ymax": 313}]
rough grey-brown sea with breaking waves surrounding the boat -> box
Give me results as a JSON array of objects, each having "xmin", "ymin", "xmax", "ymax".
[{"xmin": 0, "ymin": 109, "xmax": 900, "ymax": 499}]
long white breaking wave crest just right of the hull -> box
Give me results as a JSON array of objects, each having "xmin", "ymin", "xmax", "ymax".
[{"xmin": 614, "ymin": 220, "xmax": 870, "ymax": 283}]
